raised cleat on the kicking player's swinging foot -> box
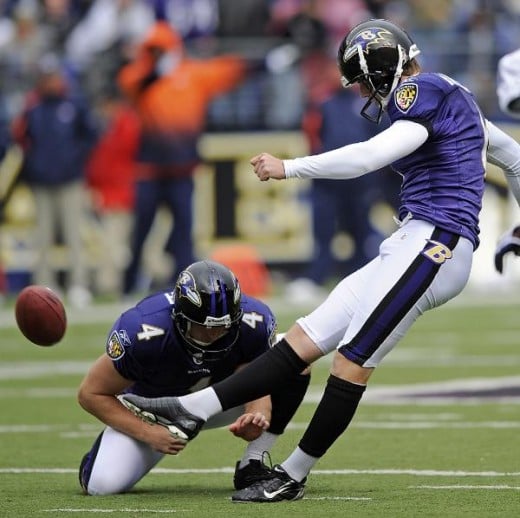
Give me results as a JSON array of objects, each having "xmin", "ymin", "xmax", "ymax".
[{"xmin": 118, "ymin": 394, "xmax": 205, "ymax": 441}]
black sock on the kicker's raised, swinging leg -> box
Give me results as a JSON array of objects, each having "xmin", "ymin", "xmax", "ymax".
[{"xmin": 213, "ymin": 339, "xmax": 307, "ymax": 410}]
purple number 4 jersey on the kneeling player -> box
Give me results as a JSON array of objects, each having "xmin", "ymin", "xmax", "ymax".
[{"xmin": 106, "ymin": 292, "xmax": 276, "ymax": 397}]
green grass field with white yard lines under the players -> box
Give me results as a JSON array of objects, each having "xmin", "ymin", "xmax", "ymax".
[{"xmin": 0, "ymin": 296, "xmax": 520, "ymax": 518}]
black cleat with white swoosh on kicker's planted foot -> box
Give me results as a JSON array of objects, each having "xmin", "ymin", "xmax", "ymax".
[{"xmin": 231, "ymin": 465, "xmax": 306, "ymax": 503}]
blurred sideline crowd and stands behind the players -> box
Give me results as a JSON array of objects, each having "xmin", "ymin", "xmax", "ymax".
[{"xmin": 0, "ymin": 0, "xmax": 520, "ymax": 307}]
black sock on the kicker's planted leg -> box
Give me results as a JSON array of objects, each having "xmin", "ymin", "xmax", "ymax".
[{"xmin": 299, "ymin": 374, "xmax": 366, "ymax": 458}]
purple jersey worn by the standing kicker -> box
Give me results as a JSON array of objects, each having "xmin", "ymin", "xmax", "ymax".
[{"xmin": 388, "ymin": 73, "xmax": 487, "ymax": 248}]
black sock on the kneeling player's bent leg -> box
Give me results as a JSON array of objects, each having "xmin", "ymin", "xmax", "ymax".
[{"xmin": 269, "ymin": 374, "xmax": 311, "ymax": 435}]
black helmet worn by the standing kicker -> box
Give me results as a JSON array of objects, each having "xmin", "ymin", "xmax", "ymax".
[{"xmin": 338, "ymin": 19, "xmax": 421, "ymax": 123}]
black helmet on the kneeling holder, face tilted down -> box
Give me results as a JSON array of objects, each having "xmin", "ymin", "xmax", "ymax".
[{"xmin": 172, "ymin": 261, "xmax": 243, "ymax": 361}]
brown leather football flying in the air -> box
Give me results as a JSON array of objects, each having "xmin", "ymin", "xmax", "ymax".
[{"xmin": 15, "ymin": 285, "xmax": 67, "ymax": 346}]
